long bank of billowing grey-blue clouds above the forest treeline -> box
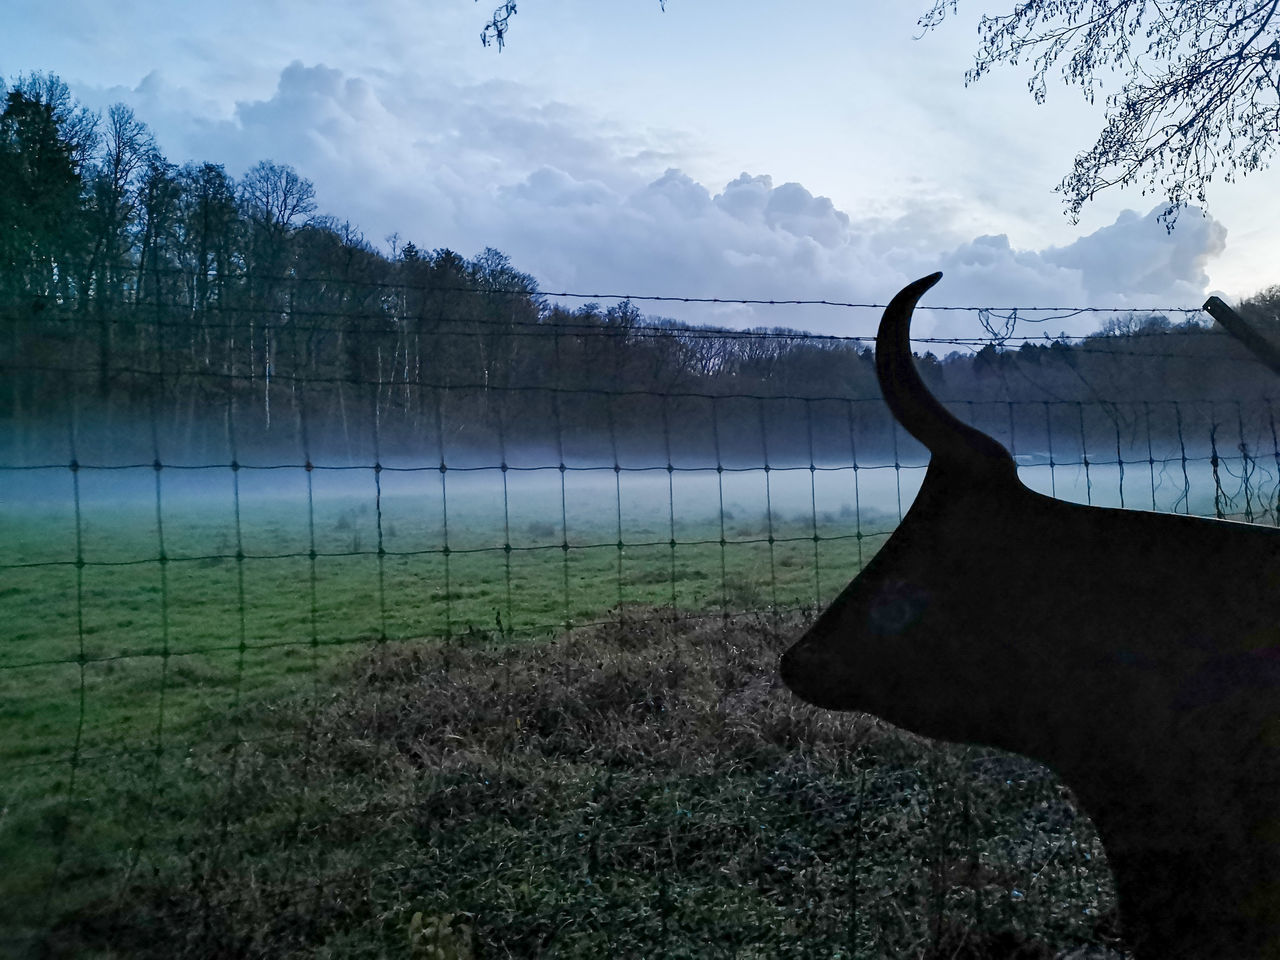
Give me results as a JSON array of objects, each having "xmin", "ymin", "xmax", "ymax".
[{"xmin": 85, "ymin": 61, "xmax": 1226, "ymax": 335}]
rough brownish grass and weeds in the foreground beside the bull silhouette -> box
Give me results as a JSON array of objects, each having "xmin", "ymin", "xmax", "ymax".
[{"xmin": 24, "ymin": 609, "xmax": 1114, "ymax": 960}]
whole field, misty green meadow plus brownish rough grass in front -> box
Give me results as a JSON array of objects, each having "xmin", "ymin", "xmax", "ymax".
[{"xmin": 0, "ymin": 458, "xmax": 1239, "ymax": 956}]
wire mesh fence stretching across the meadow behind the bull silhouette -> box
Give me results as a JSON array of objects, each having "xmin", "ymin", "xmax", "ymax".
[{"xmin": 0, "ymin": 288, "xmax": 1280, "ymax": 957}]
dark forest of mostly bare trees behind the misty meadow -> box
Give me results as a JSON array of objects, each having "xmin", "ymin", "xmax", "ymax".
[{"xmin": 0, "ymin": 74, "xmax": 1280, "ymax": 466}]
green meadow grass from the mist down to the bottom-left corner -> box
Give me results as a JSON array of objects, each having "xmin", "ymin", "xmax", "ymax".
[{"xmin": 0, "ymin": 489, "xmax": 911, "ymax": 957}]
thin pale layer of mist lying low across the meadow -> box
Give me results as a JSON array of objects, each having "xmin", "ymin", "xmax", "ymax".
[{"xmin": 0, "ymin": 451, "xmax": 1277, "ymax": 576}]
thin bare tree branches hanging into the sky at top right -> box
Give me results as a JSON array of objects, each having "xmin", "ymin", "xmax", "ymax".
[{"xmin": 920, "ymin": 0, "xmax": 1280, "ymax": 227}]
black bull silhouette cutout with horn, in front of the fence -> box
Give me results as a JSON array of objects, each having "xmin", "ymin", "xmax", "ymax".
[{"xmin": 781, "ymin": 274, "xmax": 1280, "ymax": 960}]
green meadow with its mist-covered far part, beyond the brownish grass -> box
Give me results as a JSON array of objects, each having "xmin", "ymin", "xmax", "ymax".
[{"xmin": 0, "ymin": 468, "xmax": 911, "ymax": 763}]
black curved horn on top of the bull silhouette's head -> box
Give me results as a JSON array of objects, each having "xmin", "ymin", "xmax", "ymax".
[{"xmin": 876, "ymin": 273, "xmax": 1014, "ymax": 470}]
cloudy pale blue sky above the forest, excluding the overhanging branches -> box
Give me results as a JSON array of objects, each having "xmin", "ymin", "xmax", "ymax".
[{"xmin": 0, "ymin": 0, "xmax": 1280, "ymax": 337}]
